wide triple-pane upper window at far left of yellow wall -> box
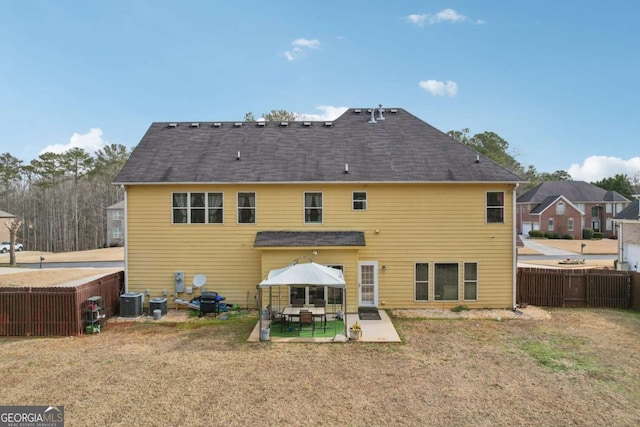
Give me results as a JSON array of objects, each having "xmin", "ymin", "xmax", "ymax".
[{"xmin": 171, "ymin": 193, "xmax": 224, "ymax": 224}]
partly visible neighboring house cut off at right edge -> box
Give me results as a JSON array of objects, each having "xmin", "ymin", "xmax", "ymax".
[{"xmin": 614, "ymin": 200, "xmax": 640, "ymax": 271}]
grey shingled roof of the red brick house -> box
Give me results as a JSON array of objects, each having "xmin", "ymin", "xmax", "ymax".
[{"xmin": 517, "ymin": 181, "xmax": 629, "ymax": 203}]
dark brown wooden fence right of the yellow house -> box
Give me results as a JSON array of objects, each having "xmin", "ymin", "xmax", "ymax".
[{"xmin": 516, "ymin": 268, "xmax": 640, "ymax": 309}]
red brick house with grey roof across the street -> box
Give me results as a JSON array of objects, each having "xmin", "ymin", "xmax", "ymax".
[{"xmin": 516, "ymin": 181, "xmax": 629, "ymax": 239}]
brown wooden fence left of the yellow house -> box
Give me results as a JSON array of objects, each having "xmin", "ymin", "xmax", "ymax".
[{"xmin": 0, "ymin": 271, "xmax": 124, "ymax": 336}]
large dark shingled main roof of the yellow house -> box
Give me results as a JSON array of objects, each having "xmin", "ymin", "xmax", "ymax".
[{"xmin": 114, "ymin": 108, "xmax": 525, "ymax": 184}]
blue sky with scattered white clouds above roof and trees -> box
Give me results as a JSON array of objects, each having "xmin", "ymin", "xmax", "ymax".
[{"xmin": 0, "ymin": 0, "xmax": 640, "ymax": 181}]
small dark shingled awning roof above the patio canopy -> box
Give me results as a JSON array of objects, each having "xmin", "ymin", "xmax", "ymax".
[{"xmin": 253, "ymin": 231, "xmax": 365, "ymax": 248}]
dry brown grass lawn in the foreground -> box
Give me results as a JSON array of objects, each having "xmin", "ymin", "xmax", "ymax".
[{"xmin": 0, "ymin": 309, "xmax": 640, "ymax": 426}]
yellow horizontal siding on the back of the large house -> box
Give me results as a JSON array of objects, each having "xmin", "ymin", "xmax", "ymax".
[{"xmin": 127, "ymin": 183, "xmax": 514, "ymax": 311}]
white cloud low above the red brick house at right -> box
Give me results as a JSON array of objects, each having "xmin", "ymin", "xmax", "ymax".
[{"xmin": 567, "ymin": 156, "xmax": 640, "ymax": 182}]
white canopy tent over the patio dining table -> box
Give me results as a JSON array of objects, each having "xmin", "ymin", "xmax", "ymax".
[{"xmin": 258, "ymin": 262, "xmax": 347, "ymax": 342}]
